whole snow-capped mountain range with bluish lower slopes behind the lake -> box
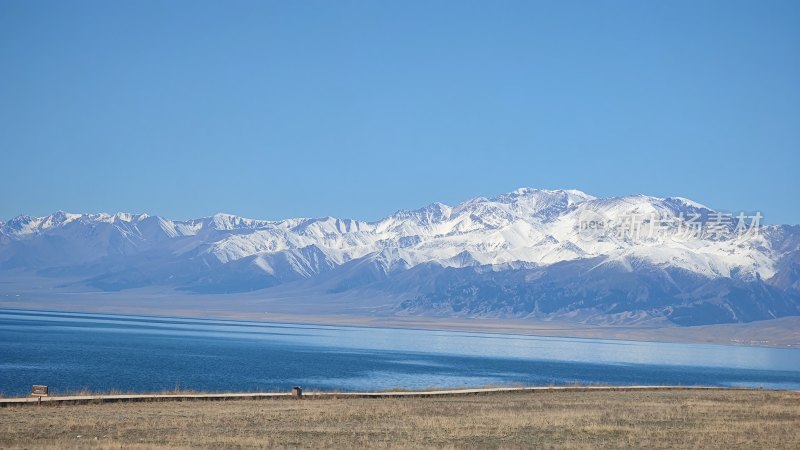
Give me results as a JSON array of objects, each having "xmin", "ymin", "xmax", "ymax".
[{"xmin": 0, "ymin": 188, "xmax": 800, "ymax": 324}]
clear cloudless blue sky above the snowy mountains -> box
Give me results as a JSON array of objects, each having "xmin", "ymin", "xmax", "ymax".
[{"xmin": 0, "ymin": 0, "xmax": 800, "ymax": 223}]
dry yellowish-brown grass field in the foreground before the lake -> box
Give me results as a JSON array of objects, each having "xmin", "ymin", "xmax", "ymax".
[{"xmin": 0, "ymin": 390, "xmax": 800, "ymax": 449}]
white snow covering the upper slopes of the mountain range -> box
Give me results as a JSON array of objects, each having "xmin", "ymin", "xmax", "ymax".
[{"xmin": 0, "ymin": 188, "xmax": 779, "ymax": 279}]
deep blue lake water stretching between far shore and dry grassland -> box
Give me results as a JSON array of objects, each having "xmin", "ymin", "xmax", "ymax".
[{"xmin": 0, "ymin": 309, "xmax": 800, "ymax": 396}]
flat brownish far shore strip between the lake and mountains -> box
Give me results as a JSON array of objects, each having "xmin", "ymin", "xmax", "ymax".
[{"xmin": 0, "ymin": 301, "xmax": 800, "ymax": 349}]
